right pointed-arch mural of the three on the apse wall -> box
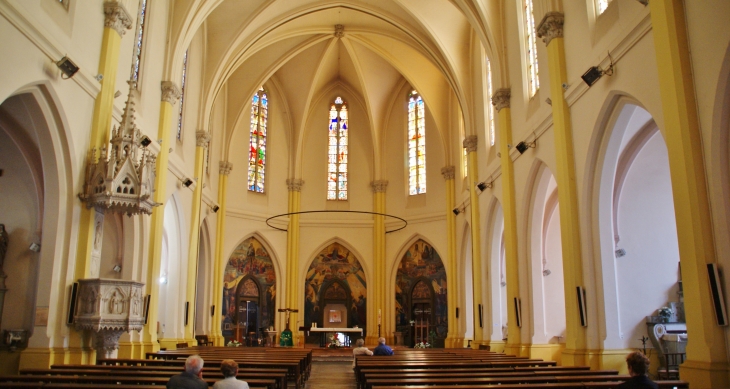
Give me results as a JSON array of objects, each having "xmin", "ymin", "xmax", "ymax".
[{"xmin": 395, "ymin": 239, "xmax": 448, "ymax": 345}]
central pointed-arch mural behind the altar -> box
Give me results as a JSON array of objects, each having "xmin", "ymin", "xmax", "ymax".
[{"xmin": 304, "ymin": 243, "xmax": 367, "ymax": 333}]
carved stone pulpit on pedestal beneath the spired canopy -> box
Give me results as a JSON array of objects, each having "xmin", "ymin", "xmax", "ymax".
[{"xmin": 74, "ymin": 278, "xmax": 144, "ymax": 358}]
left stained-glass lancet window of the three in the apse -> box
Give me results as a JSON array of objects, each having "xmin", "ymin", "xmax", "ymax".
[{"xmin": 248, "ymin": 87, "xmax": 269, "ymax": 193}]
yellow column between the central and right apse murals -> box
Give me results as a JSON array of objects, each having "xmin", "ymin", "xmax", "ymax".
[{"xmin": 367, "ymin": 180, "xmax": 386, "ymax": 344}]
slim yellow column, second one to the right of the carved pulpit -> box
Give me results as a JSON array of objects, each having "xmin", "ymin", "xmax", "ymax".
[{"xmin": 185, "ymin": 130, "xmax": 210, "ymax": 344}]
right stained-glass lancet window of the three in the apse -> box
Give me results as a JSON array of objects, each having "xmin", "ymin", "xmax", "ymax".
[{"xmin": 408, "ymin": 90, "xmax": 426, "ymax": 195}]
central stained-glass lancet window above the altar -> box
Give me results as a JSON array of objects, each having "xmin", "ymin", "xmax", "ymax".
[{"xmin": 327, "ymin": 97, "xmax": 350, "ymax": 200}]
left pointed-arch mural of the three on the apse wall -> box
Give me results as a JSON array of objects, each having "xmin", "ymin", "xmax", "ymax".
[{"xmin": 221, "ymin": 237, "xmax": 276, "ymax": 338}]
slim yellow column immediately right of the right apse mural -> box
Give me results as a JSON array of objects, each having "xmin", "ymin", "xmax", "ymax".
[{"xmin": 441, "ymin": 166, "xmax": 464, "ymax": 348}]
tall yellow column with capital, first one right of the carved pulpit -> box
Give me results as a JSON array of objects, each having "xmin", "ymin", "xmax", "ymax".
[{"xmin": 137, "ymin": 81, "xmax": 180, "ymax": 358}]
